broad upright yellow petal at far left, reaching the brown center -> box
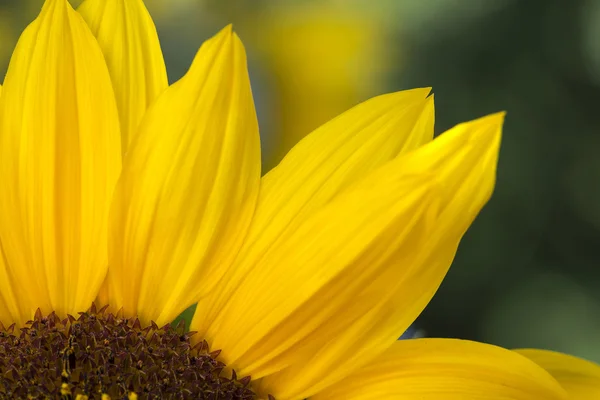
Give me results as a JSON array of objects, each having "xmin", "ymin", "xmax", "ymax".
[{"xmin": 0, "ymin": 0, "xmax": 121, "ymax": 322}]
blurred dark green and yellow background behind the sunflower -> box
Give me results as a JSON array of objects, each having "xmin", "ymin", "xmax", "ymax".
[{"xmin": 0, "ymin": 0, "xmax": 600, "ymax": 362}]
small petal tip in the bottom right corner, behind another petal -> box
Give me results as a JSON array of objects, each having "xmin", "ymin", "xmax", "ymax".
[{"xmin": 515, "ymin": 349, "xmax": 600, "ymax": 400}]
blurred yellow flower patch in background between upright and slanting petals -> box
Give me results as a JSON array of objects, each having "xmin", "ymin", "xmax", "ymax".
[{"xmin": 240, "ymin": 2, "xmax": 395, "ymax": 166}]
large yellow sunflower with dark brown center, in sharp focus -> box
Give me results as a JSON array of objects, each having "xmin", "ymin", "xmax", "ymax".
[{"xmin": 0, "ymin": 0, "xmax": 600, "ymax": 400}]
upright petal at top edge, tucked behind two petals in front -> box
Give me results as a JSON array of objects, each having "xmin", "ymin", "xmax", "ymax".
[{"xmin": 77, "ymin": 0, "xmax": 168, "ymax": 154}]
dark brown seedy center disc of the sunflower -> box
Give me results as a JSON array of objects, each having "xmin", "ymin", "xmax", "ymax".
[{"xmin": 0, "ymin": 305, "xmax": 256, "ymax": 400}]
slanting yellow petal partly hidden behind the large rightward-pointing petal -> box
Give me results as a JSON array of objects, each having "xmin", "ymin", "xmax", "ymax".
[{"xmin": 194, "ymin": 89, "xmax": 434, "ymax": 336}]
